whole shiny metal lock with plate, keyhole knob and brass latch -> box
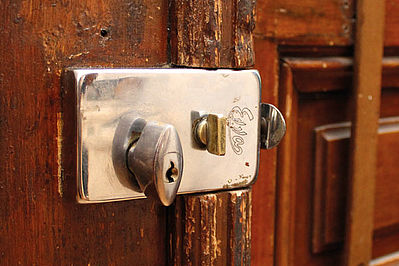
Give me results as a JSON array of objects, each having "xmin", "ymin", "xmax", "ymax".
[{"xmin": 71, "ymin": 69, "xmax": 285, "ymax": 205}]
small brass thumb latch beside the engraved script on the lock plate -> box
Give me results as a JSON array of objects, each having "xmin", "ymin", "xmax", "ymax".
[{"xmin": 193, "ymin": 114, "xmax": 227, "ymax": 156}]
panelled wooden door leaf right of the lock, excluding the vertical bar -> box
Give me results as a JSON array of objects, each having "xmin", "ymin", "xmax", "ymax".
[{"xmin": 252, "ymin": 0, "xmax": 399, "ymax": 265}]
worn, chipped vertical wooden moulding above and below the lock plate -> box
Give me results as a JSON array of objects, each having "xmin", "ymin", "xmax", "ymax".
[{"xmin": 168, "ymin": 0, "xmax": 255, "ymax": 265}]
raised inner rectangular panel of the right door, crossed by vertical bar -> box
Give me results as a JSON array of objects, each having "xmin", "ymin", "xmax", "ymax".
[{"xmin": 312, "ymin": 117, "xmax": 399, "ymax": 253}]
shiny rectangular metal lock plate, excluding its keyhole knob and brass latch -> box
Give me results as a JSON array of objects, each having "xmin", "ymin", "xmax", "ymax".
[{"xmin": 72, "ymin": 69, "xmax": 261, "ymax": 203}]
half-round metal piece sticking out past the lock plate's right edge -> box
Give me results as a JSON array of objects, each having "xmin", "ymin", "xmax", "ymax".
[{"xmin": 260, "ymin": 103, "xmax": 286, "ymax": 149}]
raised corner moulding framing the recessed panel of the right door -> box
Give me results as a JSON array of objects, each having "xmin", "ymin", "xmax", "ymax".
[{"xmin": 275, "ymin": 57, "xmax": 399, "ymax": 265}]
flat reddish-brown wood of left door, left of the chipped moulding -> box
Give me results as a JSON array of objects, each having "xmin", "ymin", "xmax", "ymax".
[{"xmin": 0, "ymin": 0, "xmax": 167, "ymax": 265}]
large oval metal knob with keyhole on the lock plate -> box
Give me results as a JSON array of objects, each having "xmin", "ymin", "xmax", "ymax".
[{"xmin": 112, "ymin": 115, "xmax": 183, "ymax": 206}]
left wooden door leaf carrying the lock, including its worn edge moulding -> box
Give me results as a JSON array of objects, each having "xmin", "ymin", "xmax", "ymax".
[{"xmin": 0, "ymin": 0, "xmax": 255, "ymax": 265}]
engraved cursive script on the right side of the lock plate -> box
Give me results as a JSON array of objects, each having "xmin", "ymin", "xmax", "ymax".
[{"xmin": 227, "ymin": 106, "xmax": 254, "ymax": 155}]
